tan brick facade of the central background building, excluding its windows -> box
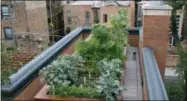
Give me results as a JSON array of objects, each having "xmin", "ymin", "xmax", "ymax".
[{"xmin": 64, "ymin": 3, "xmax": 134, "ymax": 30}]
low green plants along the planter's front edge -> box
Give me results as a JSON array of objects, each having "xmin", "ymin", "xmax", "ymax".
[{"xmin": 49, "ymin": 85, "xmax": 102, "ymax": 98}]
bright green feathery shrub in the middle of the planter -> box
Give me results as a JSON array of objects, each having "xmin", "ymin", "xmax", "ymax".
[{"xmin": 76, "ymin": 25, "xmax": 124, "ymax": 74}]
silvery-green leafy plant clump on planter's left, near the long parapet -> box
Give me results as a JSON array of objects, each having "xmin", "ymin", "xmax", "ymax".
[{"xmin": 40, "ymin": 55, "xmax": 84, "ymax": 85}]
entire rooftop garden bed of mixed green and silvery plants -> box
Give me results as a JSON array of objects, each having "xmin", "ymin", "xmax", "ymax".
[{"xmin": 40, "ymin": 10, "xmax": 127, "ymax": 100}]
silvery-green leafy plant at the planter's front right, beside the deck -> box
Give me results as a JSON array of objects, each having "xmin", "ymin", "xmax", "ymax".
[{"xmin": 96, "ymin": 59, "xmax": 124, "ymax": 100}]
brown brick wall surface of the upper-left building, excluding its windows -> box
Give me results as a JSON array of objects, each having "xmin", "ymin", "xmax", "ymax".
[{"xmin": 1, "ymin": 1, "xmax": 49, "ymax": 47}]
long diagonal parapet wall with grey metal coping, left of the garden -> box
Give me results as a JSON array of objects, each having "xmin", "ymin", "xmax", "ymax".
[{"xmin": 1, "ymin": 27, "xmax": 91, "ymax": 100}]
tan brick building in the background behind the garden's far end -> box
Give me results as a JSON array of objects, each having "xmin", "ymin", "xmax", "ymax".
[{"xmin": 63, "ymin": 1, "xmax": 135, "ymax": 33}]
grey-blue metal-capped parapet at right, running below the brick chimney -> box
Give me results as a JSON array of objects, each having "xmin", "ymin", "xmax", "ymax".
[{"xmin": 142, "ymin": 47, "xmax": 168, "ymax": 100}]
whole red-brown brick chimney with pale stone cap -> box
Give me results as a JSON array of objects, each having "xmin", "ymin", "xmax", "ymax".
[{"xmin": 142, "ymin": 1, "xmax": 172, "ymax": 78}]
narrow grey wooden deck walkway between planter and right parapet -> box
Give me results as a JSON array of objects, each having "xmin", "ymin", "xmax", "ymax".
[{"xmin": 123, "ymin": 47, "xmax": 143, "ymax": 100}]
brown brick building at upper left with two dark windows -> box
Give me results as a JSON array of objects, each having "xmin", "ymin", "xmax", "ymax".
[{"xmin": 1, "ymin": 0, "xmax": 63, "ymax": 48}]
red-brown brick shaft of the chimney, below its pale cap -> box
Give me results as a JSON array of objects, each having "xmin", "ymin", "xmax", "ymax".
[{"xmin": 143, "ymin": 15, "xmax": 170, "ymax": 77}]
